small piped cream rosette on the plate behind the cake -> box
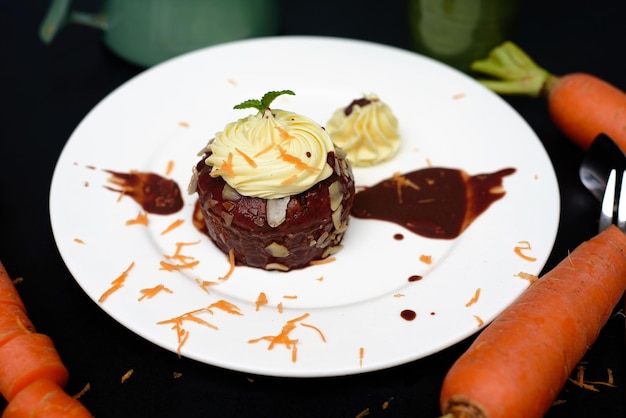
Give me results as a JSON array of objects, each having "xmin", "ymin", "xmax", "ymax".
[{"xmin": 326, "ymin": 94, "xmax": 400, "ymax": 167}]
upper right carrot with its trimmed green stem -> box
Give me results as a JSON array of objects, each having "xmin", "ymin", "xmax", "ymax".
[{"xmin": 471, "ymin": 42, "xmax": 626, "ymax": 152}]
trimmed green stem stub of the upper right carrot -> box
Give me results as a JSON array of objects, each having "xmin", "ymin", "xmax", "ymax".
[{"xmin": 470, "ymin": 41, "xmax": 553, "ymax": 97}]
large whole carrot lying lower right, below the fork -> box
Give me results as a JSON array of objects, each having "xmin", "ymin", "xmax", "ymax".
[{"xmin": 440, "ymin": 226, "xmax": 626, "ymax": 418}]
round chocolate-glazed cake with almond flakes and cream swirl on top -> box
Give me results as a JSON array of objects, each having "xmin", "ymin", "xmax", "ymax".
[{"xmin": 190, "ymin": 92, "xmax": 355, "ymax": 271}]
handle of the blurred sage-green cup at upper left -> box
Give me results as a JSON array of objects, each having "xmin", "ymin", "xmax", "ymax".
[{"xmin": 39, "ymin": 0, "xmax": 107, "ymax": 44}]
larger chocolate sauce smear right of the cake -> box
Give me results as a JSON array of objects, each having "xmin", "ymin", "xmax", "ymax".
[{"xmin": 351, "ymin": 167, "xmax": 515, "ymax": 239}]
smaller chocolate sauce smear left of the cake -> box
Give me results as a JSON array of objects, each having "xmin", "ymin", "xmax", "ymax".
[{"xmin": 104, "ymin": 170, "xmax": 183, "ymax": 215}]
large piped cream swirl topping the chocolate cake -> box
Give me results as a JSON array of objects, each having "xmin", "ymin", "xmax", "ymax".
[{"xmin": 206, "ymin": 109, "xmax": 335, "ymax": 199}]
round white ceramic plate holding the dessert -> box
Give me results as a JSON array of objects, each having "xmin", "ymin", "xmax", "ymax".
[{"xmin": 50, "ymin": 37, "xmax": 559, "ymax": 377}]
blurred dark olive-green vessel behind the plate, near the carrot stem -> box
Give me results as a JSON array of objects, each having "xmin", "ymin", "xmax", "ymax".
[{"xmin": 409, "ymin": 0, "xmax": 520, "ymax": 72}]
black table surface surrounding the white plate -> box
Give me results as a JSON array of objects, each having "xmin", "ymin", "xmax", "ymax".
[{"xmin": 0, "ymin": 0, "xmax": 626, "ymax": 417}]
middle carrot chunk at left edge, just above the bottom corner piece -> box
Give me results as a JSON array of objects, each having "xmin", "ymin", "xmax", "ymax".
[{"xmin": 0, "ymin": 333, "xmax": 69, "ymax": 402}]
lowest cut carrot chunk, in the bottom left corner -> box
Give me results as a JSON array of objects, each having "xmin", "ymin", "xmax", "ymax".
[{"xmin": 2, "ymin": 379, "xmax": 93, "ymax": 418}]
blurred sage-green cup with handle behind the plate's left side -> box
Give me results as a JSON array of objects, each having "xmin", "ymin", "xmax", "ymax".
[{"xmin": 39, "ymin": 0, "xmax": 280, "ymax": 67}]
